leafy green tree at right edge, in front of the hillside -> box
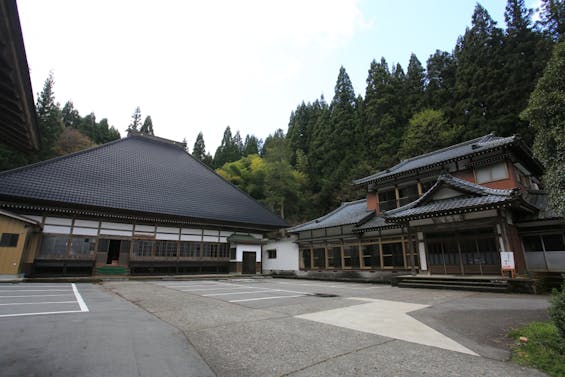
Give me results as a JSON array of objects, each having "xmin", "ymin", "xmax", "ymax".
[{"xmin": 522, "ymin": 40, "xmax": 565, "ymax": 216}]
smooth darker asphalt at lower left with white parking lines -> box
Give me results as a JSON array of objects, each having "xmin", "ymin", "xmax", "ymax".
[{"xmin": 0, "ymin": 283, "xmax": 214, "ymax": 377}]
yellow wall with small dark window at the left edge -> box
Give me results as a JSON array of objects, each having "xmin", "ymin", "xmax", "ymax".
[{"xmin": 0, "ymin": 216, "xmax": 39, "ymax": 275}]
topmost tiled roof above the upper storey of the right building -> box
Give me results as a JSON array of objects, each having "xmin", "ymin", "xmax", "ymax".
[{"xmin": 353, "ymin": 134, "xmax": 517, "ymax": 184}]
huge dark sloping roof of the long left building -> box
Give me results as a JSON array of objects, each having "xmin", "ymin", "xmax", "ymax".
[{"xmin": 0, "ymin": 135, "xmax": 287, "ymax": 228}]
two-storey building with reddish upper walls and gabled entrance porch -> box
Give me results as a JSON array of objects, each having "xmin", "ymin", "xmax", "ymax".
[{"xmin": 288, "ymin": 134, "xmax": 565, "ymax": 275}]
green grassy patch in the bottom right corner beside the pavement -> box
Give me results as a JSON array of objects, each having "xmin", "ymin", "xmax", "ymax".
[{"xmin": 509, "ymin": 322, "xmax": 565, "ymax": 376}]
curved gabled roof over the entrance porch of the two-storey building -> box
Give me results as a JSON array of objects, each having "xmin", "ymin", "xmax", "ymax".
[{"xmin": 384, "ymin": 174, "xmax": 519, "ymax": 222}]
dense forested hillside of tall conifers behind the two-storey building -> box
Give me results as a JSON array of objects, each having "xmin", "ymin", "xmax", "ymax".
[{"xmin": 216, "ymin": 0, "xmax": 565, "ymax": 223}]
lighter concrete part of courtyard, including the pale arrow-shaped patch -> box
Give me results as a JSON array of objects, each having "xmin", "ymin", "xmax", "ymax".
[{"xmin": 109, "ymin": 279, "xmax": 548, "ymax": 376}]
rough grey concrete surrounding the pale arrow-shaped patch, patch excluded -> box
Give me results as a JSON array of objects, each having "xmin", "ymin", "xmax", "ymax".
[{"xmin": 104, "ymin": 279, "xmax": 547, "ymax": 377}]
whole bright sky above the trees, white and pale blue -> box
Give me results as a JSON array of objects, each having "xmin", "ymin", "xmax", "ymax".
[{"xmin": 17, "ymin": 0, "xmax": 537, "ymax": 155}]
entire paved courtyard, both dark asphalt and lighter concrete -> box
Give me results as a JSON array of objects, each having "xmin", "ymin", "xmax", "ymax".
[{"xmin": 0, "ymin": 278, "xmax": 548, "ymax": 376}]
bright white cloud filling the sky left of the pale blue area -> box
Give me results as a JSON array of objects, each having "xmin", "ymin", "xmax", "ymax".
[{"xmin": 18, "ymin": 0, "xmax": 368, "ymax": 152}]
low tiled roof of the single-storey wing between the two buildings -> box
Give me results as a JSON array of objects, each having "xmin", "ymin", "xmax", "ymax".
[{"xmin": 287, "ymin": 199, "xmax": 375, "ymax": 233}]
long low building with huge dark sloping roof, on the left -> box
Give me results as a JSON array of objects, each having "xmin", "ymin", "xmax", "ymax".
[{"xmin": 0, "ymin": 133, "xmax": 288, "ymax": 276}]
